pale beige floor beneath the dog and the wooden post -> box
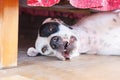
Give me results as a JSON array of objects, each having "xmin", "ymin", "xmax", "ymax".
[{"xmin": 0, "ymin": 37, "xmax": 120, "ymax": 80}]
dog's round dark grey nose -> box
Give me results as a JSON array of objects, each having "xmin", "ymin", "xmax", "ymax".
[{"xmin": 50, "ymin": 36, "xmax": 63, "ymax": 49}]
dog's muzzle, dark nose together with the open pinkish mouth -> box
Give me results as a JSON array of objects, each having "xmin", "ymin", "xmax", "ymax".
[{"xmin": 50, "ymin": 36, "xmax": 76, "ymax": 60}]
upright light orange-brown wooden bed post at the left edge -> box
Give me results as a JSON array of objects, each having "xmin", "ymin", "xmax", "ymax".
[{"xmin": 0, "ymin": 0, "xmax": 19, "ymax": 68}]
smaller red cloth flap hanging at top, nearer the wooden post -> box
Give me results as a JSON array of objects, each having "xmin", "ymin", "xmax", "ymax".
[{"xmin": 27, "ymin": 0, "xmax": 60, "ymax": 7}]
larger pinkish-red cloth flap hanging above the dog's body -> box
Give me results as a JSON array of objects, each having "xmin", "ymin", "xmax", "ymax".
[{"xmin": 70, "ymin": 0, "xmax": 120, "ymax": 11}]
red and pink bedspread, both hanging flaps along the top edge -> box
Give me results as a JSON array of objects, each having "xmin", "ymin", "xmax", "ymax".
[{"xmin": 27, "ymin": 0, "xmax": 120, "ymax": 11}]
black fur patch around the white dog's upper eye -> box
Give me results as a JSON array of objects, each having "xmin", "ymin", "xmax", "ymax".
[{"xmin": 39, "ymin": 22, "xmax": 59, "ymax": 37}]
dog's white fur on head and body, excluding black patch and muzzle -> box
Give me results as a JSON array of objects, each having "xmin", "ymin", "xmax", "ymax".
[{"xmin": 27, "ymin": 10, "xmax": 120, "ymax": 60}]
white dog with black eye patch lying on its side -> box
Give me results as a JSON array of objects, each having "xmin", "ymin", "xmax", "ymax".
[{"xmin": 27, "ymin": 11, "xmax": 120, "ymax": 60}]
